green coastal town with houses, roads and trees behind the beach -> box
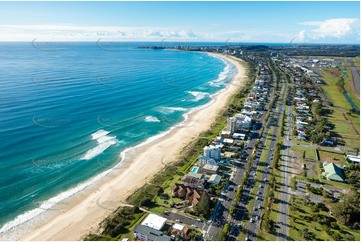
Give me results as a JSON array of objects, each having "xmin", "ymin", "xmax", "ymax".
[{"xmin": 85, "ymin": 43, "xmax": 360, "ymax": 241}]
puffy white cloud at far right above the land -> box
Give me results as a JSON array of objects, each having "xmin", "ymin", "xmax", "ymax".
[{"xmin": 299, "ymin": 18, "xmax": 358, "ymax": 39}]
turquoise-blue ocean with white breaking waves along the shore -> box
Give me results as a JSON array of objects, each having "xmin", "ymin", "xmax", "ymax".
[{"xmin": 0, "ymin": 40, "xmax": 236, "ymax": 233}]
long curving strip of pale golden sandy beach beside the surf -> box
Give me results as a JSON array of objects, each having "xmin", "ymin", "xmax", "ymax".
[{"xmin": 20, "ymin": 54, "xmax": 246, "ymax": 240}]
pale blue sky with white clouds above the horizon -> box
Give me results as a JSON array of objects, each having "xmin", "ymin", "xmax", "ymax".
[{"xmin": 0, "ymin": 1, "xmax": 360, "ymax": 44}]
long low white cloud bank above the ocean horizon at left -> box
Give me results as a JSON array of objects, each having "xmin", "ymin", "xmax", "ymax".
[{"xmin": 0, "ymin": 25, "xmax": 202, "ymax": 41}]
